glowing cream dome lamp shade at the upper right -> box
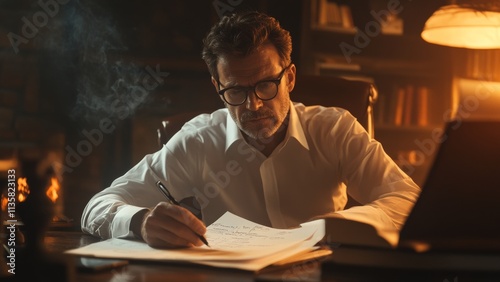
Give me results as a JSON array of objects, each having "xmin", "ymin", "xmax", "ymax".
[{"xmin": 421, "ymin": 5, "xmax": 500, "ymax": 49}]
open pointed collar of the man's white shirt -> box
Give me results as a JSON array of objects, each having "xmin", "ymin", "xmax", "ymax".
[{"xmin": 226, "ymin": 102, "xmax": 309, "ymax": 151}]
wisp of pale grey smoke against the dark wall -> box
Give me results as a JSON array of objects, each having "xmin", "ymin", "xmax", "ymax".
[{"xmin": 42, "ymin": 0, "xmax": 149, "ymax": 123}]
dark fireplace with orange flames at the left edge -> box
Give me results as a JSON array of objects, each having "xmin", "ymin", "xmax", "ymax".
[{"xmin": 0, "ymin": 76, "xmax": 72, "ymax": 230}]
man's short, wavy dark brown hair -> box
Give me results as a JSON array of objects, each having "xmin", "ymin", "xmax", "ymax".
[{"xmin": 202, "ymin": 12, "xmax": 292, "ymax": 79}]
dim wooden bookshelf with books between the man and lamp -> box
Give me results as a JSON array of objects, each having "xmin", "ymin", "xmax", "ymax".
[{"xmin": 299, "ymin": 0, "xmax": 452, "ymax": 185}]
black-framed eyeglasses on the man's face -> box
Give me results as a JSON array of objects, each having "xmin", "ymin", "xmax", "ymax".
[{"xmin": 217, "ymin": 63, "xmax": 292, "ymax": 106}]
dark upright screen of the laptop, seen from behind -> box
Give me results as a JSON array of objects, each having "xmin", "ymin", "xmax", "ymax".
[{"xmin": 399, "ymin": 121, "xmax": 500, "ymax": 250}]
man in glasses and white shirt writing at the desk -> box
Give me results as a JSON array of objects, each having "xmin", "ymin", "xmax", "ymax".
[{"xmin": 82, "ymin": 12, "xmax": 420, "ymax": 247}]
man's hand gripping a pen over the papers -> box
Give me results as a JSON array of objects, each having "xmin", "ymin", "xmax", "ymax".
[{"xmin": 141, "ymin": 202, "xmax": 206, "ymax": 248}]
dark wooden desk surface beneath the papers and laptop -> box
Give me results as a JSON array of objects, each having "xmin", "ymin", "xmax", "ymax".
[{"xmin": 6, "ymin": 231, "xmax": 500, "ymax": 282}]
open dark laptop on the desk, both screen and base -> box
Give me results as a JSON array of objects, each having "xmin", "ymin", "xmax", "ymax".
[{"xmin": 323, "ymin": 120, "xmax": 500, "ymax": 272}]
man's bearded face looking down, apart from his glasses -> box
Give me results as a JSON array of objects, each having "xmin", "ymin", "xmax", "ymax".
[{"xmin": 212, "ymin": 44, "xmax": 295, "ymax": 140}]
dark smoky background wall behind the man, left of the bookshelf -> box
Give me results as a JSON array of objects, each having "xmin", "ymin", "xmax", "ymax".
[{"xmin": 0, "ymin": 0, "xmax": 300, "ymax": 228}]
